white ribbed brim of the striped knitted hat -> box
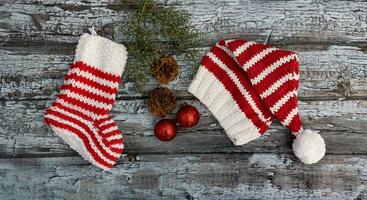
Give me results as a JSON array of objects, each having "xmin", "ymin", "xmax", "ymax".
[{"xmin": 188, "ymin": 67, "xmax": 261, "ymax": 145}]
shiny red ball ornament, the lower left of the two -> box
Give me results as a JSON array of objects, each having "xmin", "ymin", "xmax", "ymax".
[{"xmin": 154, "ymin": 119, "xmax": 177, "ymax": 142}]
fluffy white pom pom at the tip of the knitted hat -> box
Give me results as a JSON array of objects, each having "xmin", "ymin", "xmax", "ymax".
[{"xmin": 293, "ymin": 130, "xmax": 326, "ymax": 164}]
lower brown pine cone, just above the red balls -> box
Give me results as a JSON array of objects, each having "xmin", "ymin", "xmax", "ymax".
[{"xmin": 148, "ymin": 87, "xmax": 176, "ymax": 117}]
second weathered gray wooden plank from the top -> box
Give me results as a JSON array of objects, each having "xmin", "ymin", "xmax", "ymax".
[{"xmin": 0, "ymin": 44, "xmax": 367, "ymax": 100}]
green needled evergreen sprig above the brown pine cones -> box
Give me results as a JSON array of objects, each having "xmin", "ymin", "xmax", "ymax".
[{"xmin": 123, "ymin": 0, "xmax": 202, "ymax": 91}]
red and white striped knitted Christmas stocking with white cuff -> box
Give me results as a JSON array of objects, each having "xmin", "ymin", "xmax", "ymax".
[{"xmin": 45, "ymin": 30, "xmax": 127, "ymax": 170}]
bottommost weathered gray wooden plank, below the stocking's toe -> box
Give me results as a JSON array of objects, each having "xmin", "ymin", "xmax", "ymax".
[{"xmin": 0, "ymin": 154, "xmax": 367, "ymax": 200}]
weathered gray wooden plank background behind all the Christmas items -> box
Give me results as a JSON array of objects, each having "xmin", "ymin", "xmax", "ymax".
[{"xmin": 0, "ymin": 0, "xmax": 367, "ymax": 200}]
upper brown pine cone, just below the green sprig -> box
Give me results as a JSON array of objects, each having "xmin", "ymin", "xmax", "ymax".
[{"xmin": 152, "ymin": 55, "xmax": 179, "ymax": 84}]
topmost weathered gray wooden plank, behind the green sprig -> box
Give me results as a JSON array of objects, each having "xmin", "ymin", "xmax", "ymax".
[{"xmin": 0, "ymin": 0, "xmax": 367, "ymax": 45}]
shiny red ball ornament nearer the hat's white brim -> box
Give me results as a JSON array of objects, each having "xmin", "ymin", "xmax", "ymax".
[{"xmin": 177, "ymin": 105, "xmax": 200, "ymax": 128}]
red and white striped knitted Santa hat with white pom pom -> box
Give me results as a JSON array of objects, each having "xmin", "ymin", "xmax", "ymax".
[{"xmin": 189, "ymin": 39, "xmax": 326, "ymax": 164}]
